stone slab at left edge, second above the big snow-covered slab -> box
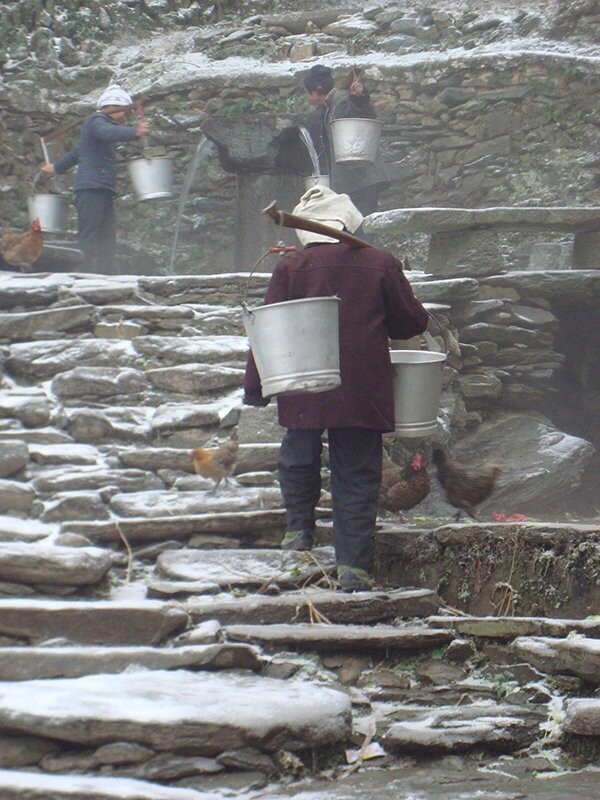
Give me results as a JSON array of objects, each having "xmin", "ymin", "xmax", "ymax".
[{"xmin": 0, "ymin": 599, "xmax": 188, "ymax": 645}]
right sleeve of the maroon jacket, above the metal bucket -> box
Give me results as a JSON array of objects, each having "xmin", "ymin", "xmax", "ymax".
[{"xmin": 383, "ymin": 256, "xmax": 429, "ymax": 339}]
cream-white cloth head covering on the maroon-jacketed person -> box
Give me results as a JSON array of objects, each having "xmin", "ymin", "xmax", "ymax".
[{"xmin": 292, "ymin": 184, "xmax": 363, "ymax": 245}]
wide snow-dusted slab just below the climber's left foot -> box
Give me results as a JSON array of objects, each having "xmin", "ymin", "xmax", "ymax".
[{"xmin": 156, "ymin": 547, "xmax": 335, "ymax": 586}]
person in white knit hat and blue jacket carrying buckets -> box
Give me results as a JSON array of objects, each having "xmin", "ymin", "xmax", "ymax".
[{"xmin": 41, "ymin": 83, "xmax": 150, "ymax": 274}]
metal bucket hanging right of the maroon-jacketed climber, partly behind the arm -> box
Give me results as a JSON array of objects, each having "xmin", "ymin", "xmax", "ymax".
[{"xmin": 390, "ymin": 350, "xmax": 446, "ymax": 438}]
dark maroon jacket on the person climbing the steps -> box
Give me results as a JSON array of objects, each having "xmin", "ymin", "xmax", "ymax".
[{"xmin": 244, "ymin": 243, "xmax": 428, "ymax": 431}]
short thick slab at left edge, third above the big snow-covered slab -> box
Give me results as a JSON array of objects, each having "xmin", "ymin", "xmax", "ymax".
[{"xmin": 0, "ymin": 542, "xmax": 114, "ymax": 586}]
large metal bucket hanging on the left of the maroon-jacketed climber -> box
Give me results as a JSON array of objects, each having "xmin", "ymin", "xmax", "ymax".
[{"xmin": 242, "ymin": 297, "xmax": 341, "ymax": 397}]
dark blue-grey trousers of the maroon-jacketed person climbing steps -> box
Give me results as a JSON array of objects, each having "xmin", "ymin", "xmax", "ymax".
[{"xmin": 279, "ymin": 428, "xmax": 382, "ymax": 572}]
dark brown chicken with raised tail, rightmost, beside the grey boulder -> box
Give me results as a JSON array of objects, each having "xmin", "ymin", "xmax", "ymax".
[{"xmin": 432, "ymin": 447, "xmax": 500, "ymax": 522}]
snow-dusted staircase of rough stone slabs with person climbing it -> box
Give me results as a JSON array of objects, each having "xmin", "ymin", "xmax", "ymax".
[{"xmin": 0, "ymin": 274, "xmax": 600, "ymax": 800}]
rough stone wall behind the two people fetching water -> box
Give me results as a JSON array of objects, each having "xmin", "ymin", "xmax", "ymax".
[{"xmin": 0, "ymin": 2, "xmax": 600, "ymax": 273}]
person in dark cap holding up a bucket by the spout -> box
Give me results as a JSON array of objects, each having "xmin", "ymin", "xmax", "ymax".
[{"xmin": 304, "ymin": 64, "xmax": 390, "ymax": 217}]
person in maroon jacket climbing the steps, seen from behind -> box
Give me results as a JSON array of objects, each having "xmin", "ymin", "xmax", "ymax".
[{"xmin": 244, "ymin": 186, "xmax": 429, "ymax": 591}]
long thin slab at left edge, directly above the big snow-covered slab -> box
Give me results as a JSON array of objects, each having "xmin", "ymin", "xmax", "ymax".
[{"xmin": 0, "ymin": 644, "xmax": 262, "ymax": 681}]
